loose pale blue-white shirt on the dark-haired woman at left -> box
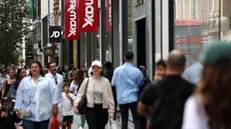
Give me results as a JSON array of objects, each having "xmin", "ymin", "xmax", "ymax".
[{"xmin": 14, "ymin": 76, "xmax": 61, "ymax": 122}]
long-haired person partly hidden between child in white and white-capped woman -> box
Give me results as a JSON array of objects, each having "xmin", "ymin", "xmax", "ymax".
[{"xmin": 70, "ymin": 70, "xmax": 85, "ymax": 129}]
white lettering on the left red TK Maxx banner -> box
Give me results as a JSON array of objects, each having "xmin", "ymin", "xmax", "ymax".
[{"xmin": 67, "ymin": 0, "xmax": 77, "ymax": 37}]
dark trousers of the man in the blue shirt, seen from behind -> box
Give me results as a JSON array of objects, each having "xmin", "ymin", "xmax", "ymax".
[{"xmin": 120, "ymin": 102, "xmax": 141, "ymax": 129}]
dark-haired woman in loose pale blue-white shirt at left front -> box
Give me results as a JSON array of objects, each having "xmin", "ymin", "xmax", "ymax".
[{"xmin": 14, "ymin": 61, "xmax": 61, "ymax": 129}]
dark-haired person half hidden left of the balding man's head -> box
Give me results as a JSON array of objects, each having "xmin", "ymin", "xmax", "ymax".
[{"xmin": 154, "ymin": 59, "xmax": 167, "ymax": 82}]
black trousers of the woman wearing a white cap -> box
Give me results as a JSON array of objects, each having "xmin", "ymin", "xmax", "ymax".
[{"xmin": 85, "ymin": 104, "xmax": 108, "ymax": 129}]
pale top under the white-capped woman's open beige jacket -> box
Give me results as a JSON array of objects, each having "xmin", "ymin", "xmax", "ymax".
[{"xmin": 94, "ymin": 80, "xmax": 103, "ymax": 104}]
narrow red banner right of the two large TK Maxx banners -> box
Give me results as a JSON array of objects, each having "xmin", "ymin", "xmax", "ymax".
[{"xmin": 106, "ymin": 0, "xmax": 112, "ymax": 32}]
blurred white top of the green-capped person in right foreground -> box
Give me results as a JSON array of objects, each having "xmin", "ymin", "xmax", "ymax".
[{"xmin": 182, "ymin": 96, "xmax": 209, "ymax": 129}]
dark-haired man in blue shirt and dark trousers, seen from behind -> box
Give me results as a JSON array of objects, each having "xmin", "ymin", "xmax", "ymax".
[{"xmin": 112, "ymin": 51, "xmax": 143, "ymax": 129}]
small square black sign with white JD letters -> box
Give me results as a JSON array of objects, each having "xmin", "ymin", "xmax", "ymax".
[{"xmin": 49, "ymin": 26, "xmax": 62, "ymax": 43}]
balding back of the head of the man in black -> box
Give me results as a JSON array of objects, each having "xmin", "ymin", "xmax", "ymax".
[{"xmin": 168, "ymin": 51, "xmax": 186, "ymax": 70}]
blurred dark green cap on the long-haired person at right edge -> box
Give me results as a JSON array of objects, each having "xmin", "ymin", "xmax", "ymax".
[{"xmin": 203, "ymin": 41, "xmax": 231, "ymax": 67}]
